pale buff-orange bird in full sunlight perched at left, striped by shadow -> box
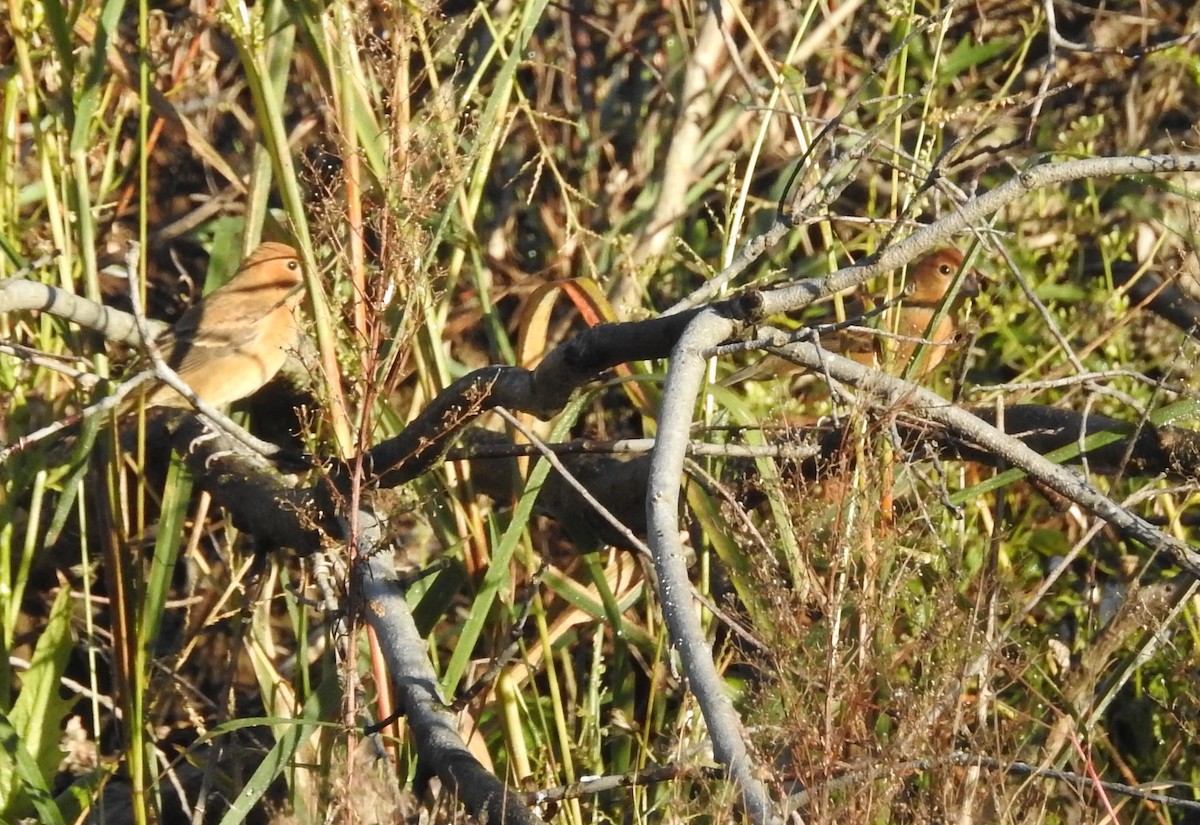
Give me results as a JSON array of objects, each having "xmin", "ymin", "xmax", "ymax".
[{"xmin": 116, "ymin": 242, "xmax": 304, "ymax": 417}]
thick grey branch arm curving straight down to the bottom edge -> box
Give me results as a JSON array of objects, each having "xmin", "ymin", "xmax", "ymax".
[{"xmin": 646, "ymin": 311, "xmax": 778, "ymax": 823}]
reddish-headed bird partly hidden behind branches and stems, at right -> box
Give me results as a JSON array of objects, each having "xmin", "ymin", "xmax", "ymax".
[{"xmin": 721, "ymin": 247, "xmax": 979, "ymax": 386}]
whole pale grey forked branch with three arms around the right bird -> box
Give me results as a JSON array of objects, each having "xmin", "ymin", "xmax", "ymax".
[{"xmin": 647, "ymin": 155, "xmax": 1200, "ymax": 821}]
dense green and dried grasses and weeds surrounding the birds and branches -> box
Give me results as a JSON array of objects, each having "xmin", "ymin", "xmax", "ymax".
[{"xmin": 0, "ymin": 0, "xmax": 1200, "ymax": 823}]
